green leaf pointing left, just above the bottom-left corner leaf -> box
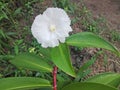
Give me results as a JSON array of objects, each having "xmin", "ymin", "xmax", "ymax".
[{"xmin": 10, "ymin": 53, "xmax": 52, "ymax": 72}]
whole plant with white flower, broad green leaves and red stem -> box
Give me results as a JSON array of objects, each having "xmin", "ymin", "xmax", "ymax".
[{"xmin": 0, "ymin": 8, "xmax": 120, "ymax": 90}]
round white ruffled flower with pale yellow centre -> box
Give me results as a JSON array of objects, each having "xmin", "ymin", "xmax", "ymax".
[{"xmin": 31, "ymin": 8, "xmax": 72, "ymax": 48}]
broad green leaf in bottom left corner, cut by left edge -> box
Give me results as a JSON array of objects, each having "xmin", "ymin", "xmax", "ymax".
[{"xmin": 0, "ymin": 77, "xmax": 52, "ymax": 90}]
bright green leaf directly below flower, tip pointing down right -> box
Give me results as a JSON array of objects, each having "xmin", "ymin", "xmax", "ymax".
[{"xmin": 51, "ymin": 44, "xmax": 75, "ymax": 77}]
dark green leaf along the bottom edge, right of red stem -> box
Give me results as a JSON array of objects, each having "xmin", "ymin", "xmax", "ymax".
[{"xmin": 62, "ymin": 82, "xmax": 117, "ymax": 90}]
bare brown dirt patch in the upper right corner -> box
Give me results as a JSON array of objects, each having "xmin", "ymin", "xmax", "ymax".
[{"xmin": 83, "ymin": 0, "xmax": 120, "ymax": 32}]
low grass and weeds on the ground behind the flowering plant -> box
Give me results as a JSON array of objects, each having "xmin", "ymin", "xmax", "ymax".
[{"xmin": 0, "ymin": 0, "xmax": 120, "ymax": 83}]
